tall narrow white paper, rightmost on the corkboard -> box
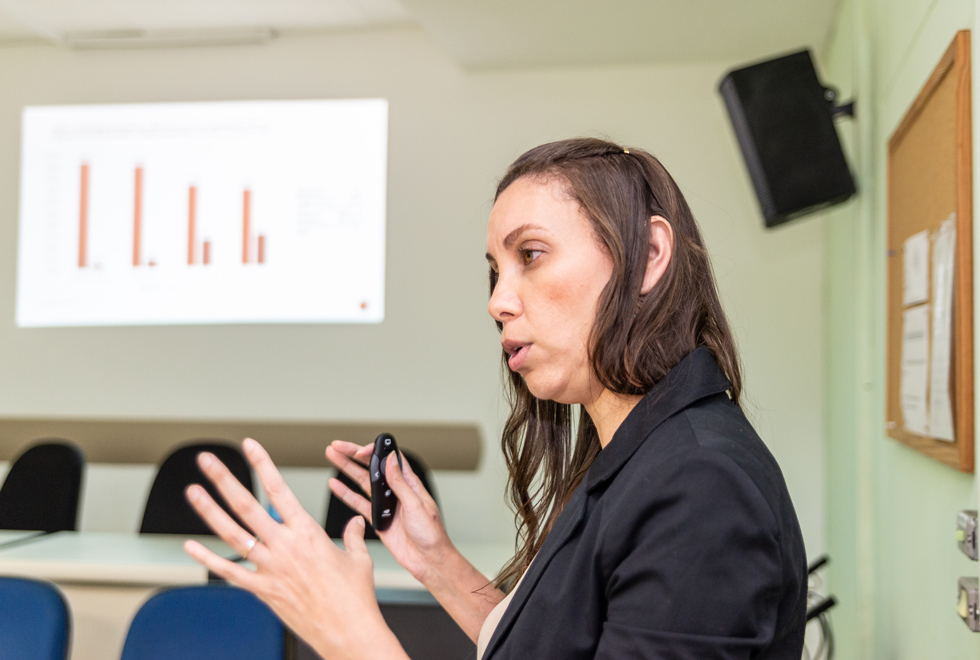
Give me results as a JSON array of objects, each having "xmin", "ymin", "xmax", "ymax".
[{"xmin": 929, "ymin": 213, "xmax": 956, "ymax": 442}]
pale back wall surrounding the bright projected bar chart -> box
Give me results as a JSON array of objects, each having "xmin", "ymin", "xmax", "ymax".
[{"xmin": 0, "ymin": 28, "xmax": 824, "ymax": 555}]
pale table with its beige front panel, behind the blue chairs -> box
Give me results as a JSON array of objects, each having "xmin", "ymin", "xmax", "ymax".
[{"xmin": 0, "ymin": 532, "xmax": 513, "ymax": 660}]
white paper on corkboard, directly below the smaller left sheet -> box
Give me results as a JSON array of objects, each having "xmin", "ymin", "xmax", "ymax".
[{"xmin": 901, "ymin": 305, "xmax": 929, "ymax": 435}]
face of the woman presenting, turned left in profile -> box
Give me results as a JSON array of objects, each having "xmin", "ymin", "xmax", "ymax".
[{"xmin": 487, "ymin": 177, "xmax": 613, "ymax": 403}]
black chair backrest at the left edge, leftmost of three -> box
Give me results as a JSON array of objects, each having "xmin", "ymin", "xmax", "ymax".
[{"xmin": 0, "ymin": 440, "xmax": 85, "ymax": 532}]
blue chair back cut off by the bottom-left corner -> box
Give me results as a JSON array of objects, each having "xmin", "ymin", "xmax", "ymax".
[{"xmin": 0, "ymin": 577, "xmax": 71, "ymax": 660}]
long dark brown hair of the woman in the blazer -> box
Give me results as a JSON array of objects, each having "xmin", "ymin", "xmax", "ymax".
[{"xmin": 490, "ymin": 138, "xmax": 742, "ymax": 585}]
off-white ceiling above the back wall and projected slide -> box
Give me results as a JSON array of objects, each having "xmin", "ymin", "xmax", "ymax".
[{"xmin": 0, "ymin": 0, "xmax": 837, "ymax": 68}]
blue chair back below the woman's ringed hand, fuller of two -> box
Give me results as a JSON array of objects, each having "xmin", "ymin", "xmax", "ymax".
[{"xmin": 122, "ymin": 585, "xmax": 285, "ymax": 660}]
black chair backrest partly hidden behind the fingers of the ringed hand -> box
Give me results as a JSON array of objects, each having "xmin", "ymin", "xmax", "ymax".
[{"xmin": 140, "ymin": 440, "xmax": 255, "ymax": 534}]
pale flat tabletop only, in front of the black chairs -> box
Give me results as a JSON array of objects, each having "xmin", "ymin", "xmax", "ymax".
[{"xmin": 0, "ymin": 532, "xmax": 513, "ymax": 591}]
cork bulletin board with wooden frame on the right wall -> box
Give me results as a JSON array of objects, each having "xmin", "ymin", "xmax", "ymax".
[{"xmin": 886, "ymin": 30, "xmax": 974, "ymax": 472}]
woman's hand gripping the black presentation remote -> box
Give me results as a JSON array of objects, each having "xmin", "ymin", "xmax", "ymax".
[{"xmin": 327, "ymin": 440, "xmax": 455, "ymax": 584}]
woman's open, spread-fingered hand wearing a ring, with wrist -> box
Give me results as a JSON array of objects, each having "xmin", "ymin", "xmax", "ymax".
[{"xmin": 184, "ymin": 440, "xmax": 407, "ymax": 658}]
